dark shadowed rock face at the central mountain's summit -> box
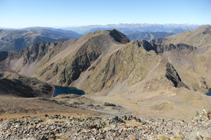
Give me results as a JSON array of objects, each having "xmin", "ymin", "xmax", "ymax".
[{"xmin": 108, "ymin": 29, "xmax": 130, "ymax": 44}]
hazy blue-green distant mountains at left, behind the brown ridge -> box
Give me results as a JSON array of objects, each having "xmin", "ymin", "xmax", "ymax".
[{"xmin": 0, "ymin": 27, "xmax": 82, "ymax": 51}]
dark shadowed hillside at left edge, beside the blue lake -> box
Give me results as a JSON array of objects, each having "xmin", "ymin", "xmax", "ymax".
[{"xmin": 0, "ymin": 72, "xmax": 53, "ymax": 97}]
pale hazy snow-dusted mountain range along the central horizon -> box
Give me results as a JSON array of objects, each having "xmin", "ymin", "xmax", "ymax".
[{"xmin": 62, "ymin": 23, "xmax": 200, "ymax": 34}]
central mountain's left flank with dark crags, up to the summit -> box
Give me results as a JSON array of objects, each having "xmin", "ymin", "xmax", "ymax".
[{"xmin": 34, "ymin": 30, "xmax": 129, "ymax": 85}]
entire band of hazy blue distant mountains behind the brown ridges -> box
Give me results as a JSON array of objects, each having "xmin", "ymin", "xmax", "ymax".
[{"xmin": 0, "ymin": 24, "xmax": 199, "ymax": 51}]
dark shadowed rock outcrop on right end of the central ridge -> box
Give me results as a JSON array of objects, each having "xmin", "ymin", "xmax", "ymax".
[{"xmin": 166, "ymin": 63, "xmax": 189, "ymax": 89}]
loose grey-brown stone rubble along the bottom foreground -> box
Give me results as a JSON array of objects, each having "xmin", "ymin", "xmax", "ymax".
[{"xmin": 0, "ymin": 112, "xmax": 211, "ymax": 140}]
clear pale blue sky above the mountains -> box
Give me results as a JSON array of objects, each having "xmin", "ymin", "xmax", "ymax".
[{"xmin": 0, "ymin": 0, "xmax": 211, "ymax": 28}]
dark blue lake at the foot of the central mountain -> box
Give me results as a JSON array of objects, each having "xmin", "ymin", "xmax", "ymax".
[{"xmin": 53, "ymin": 86, "xmax": 85, "ymax": 97}]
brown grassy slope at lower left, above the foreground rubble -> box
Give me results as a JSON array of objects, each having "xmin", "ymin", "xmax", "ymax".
[{"xmin": 0, "ymin": 96, "xmax": 101, "ymax": 121}]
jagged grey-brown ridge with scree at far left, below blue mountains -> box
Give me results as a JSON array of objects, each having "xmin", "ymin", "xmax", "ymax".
[{"xmin": 0, "ymin": 39, "xmax": 76, "ymax": 76}]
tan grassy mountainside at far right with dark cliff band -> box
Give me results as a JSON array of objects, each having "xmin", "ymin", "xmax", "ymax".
[{"xmin": 148, "ymin": 25, "xmax": 211, "ymax": 92}]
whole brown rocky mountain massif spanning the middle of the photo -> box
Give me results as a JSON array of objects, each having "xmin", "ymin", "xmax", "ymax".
[{"xmin": 0, "ymin": 26, "xmax": 211, "ymax": 117}]
